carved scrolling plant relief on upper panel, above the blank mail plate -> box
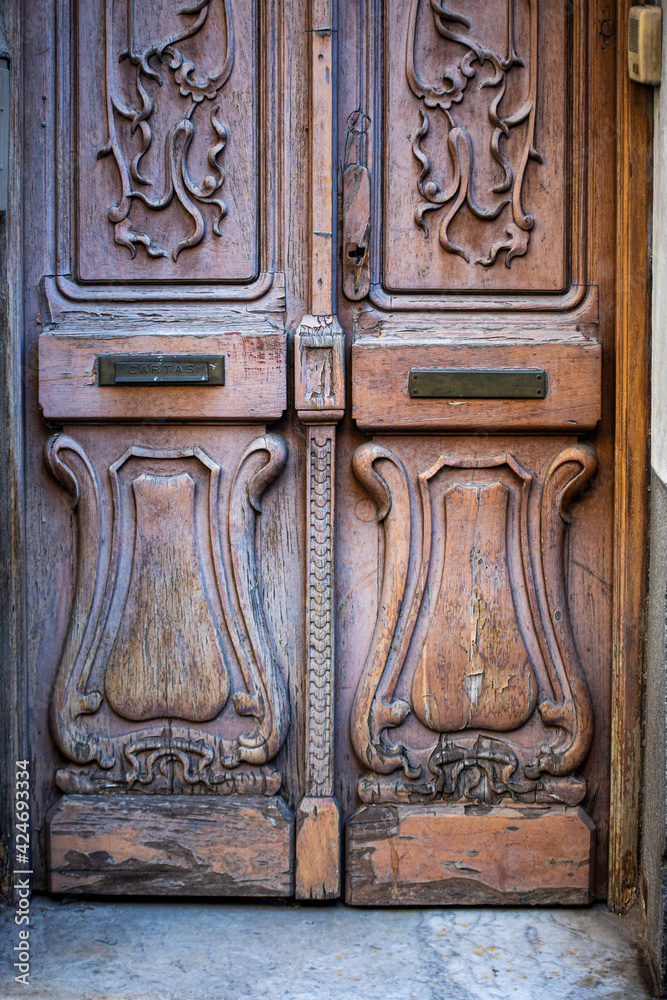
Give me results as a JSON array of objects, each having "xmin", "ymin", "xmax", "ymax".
[{"xmin": 406, "ymin": 0, "xmax": 541, "ymax": 267}]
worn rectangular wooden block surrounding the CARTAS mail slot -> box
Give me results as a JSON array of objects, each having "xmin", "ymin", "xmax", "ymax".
[{"xmin": 39, "ymin": 333, "xmax": 287, "ymax": 420}]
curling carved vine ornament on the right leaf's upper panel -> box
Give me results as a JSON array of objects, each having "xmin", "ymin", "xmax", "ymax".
[{"xmin": 406, "ymin": 0, "xmax": 541, "ymax": 267}]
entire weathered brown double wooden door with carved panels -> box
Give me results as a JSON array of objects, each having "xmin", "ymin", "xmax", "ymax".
[{"xmin": 24, "ymin": 0, "xmax": 616, "ymax": 904}]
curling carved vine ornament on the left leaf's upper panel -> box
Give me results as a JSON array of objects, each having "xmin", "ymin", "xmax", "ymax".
[{"xmin": 98, "ymin": 0, "xmax": 234, "ymax": 260}]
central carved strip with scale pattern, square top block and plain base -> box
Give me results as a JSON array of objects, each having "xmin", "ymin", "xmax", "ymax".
[{"xmin": 295, "ymin": 316, "xmax": 345, "ymax": 899}]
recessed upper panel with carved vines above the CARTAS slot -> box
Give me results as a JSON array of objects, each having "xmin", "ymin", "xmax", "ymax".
[{"xmin": 74, "ymin": 0, "xmax": 259, "ymax": 282}]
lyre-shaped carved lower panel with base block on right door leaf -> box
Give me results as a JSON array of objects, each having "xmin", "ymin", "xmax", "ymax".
[{"xmin": 346, "ymin": 437, "xmax": 597, "ymax": 905}]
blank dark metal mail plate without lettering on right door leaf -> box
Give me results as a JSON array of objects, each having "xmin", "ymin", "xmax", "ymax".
[{"xmin": 408, "ymin": 368, "xmax": 548, "ymax": 399}]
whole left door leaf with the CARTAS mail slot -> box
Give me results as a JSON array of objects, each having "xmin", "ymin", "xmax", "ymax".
[{"xmin": 25, "ymin": 0, "xmax": 318, "ymax": 896}]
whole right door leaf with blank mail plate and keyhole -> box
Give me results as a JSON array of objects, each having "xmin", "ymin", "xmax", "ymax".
[{"xmin": 337, "ymin": 0, "xmax": 614, "ymax": 904}]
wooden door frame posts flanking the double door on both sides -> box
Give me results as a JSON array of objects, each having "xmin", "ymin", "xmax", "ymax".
[{"xmin": 0, "ymin": 0, "xmax": 653, "ymax": 912}]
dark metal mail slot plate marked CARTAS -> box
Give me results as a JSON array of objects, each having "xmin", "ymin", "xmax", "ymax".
[{"xmin": 97, "ymin": 354, "xmax": 225, "ymax": 386}]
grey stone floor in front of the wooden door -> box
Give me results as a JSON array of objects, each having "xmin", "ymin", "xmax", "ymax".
[{"xmin": 0, "ymin": 896, "xmax": 651, "ymax": 1000}]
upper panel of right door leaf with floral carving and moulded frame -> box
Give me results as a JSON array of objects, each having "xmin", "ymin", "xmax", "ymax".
[{"xmin": 378, "ymin": 0, "xmax": 572, "ymax": 296}]
